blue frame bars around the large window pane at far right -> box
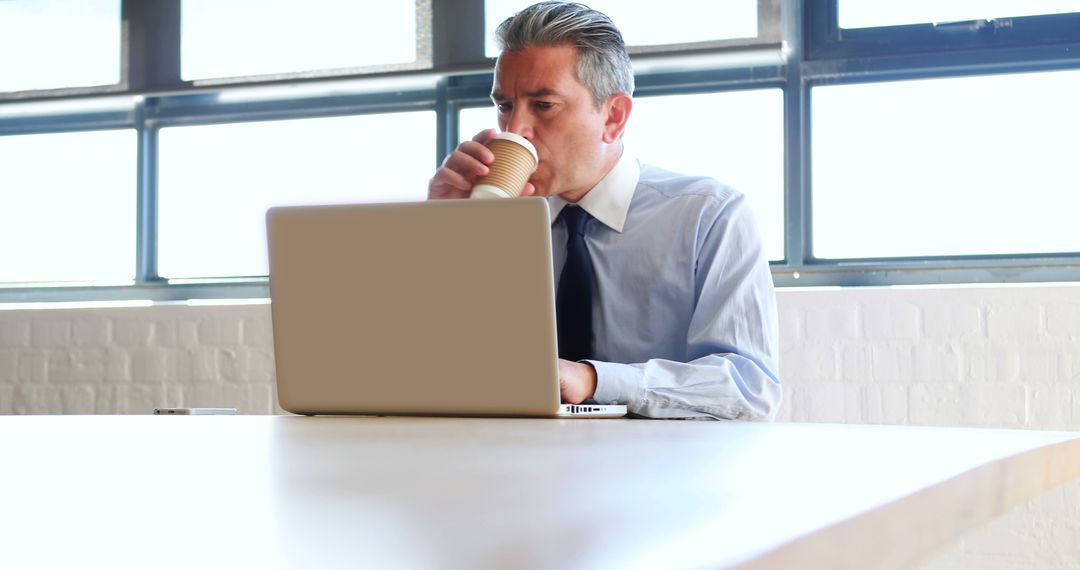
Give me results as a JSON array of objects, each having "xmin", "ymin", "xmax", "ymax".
[{"xmin": 794, "ymin": 0, "xmax": 1080, "ymax": 286}]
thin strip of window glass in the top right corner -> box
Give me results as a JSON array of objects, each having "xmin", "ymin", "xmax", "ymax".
[{"xmin": 839, "ymin": 0, "xmax": 1080, "ymax": 29}]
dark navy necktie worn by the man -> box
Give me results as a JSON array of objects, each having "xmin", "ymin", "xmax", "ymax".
[{"xmin": 555, "ymin": 206, "xmax": 595, "ymax": 361}]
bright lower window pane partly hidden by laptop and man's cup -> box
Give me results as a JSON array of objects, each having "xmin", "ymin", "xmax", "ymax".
[{"xmin": 158, "ymin": 111, "xmax": 435, "ymax": 279}]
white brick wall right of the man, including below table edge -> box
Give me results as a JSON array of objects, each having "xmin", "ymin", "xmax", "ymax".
[{"xmin": 779, "ymin": 286, "xmax": 1080, "ymax": 570}]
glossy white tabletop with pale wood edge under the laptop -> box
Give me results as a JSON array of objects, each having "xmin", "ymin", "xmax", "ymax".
[{"xmin": 0, "ymin": 416, "xmax": 1080, "ymax": 568}]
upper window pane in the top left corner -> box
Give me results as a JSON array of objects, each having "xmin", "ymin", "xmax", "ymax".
[{"xmin": 0, "ymin": 0, "xmax": 121, "ymax": 92}]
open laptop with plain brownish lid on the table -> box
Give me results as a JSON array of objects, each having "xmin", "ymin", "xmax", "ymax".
[{"xmin": 267, "ymin": 198, "xmax": 626, "ymax": 418}]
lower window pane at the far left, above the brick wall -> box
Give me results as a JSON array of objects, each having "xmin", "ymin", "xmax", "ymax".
[{"xmin": 0, "ymin": 130, "xmax": 137, "ymax": 283}]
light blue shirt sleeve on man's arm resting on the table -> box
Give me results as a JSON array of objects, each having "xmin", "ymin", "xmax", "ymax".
[{"xmin": 574, "ymin": 196, "xmax": 781, "ymax": 419}]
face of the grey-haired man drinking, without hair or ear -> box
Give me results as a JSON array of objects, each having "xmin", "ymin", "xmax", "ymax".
[{"xmin": 491, "ymin": 45, "xmax": 610, "ymax": 195}]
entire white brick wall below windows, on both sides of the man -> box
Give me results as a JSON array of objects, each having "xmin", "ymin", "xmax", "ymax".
[{"xmin": 0, "ymin": 286, "xmax": 1080, "ymax": 570}]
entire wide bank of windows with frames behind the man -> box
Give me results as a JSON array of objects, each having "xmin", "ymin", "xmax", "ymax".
[{"xmin": 0, "ymin": 0, "xmax": 1080, "ymax": 302}]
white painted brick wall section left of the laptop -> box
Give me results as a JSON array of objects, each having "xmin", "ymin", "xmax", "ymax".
[{"xmin": 0, "ymin": 304, "xmax": 279, "ymax": 413}]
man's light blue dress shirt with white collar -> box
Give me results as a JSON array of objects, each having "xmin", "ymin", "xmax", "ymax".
[{"xmin": 548, "ymin": 152, "xmax": 781, "ymax": 420}]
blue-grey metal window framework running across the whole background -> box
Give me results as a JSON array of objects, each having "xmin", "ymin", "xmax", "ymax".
[{"xmin": 0, "ymin": 0, "xmax": 1080, "ymax": 302}]
